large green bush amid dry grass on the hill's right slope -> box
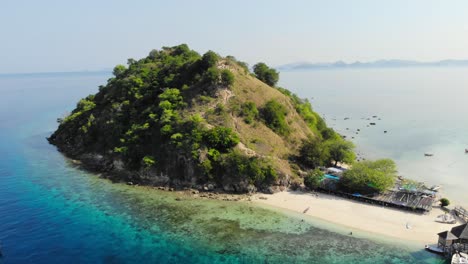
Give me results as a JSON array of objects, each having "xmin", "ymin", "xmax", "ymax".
[{"xmin": 261, "ymin": 100, "xmax": 290, "ymax": 136}]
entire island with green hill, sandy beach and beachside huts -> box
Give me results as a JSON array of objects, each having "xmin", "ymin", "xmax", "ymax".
[{"xmin": 48, "ymin": 44, "xmax": 466, "ymax": 258}]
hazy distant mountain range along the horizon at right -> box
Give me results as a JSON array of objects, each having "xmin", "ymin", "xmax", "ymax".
[{"xmin": 276, "ymin": 60, "xmax": 468, "ymax": 71}]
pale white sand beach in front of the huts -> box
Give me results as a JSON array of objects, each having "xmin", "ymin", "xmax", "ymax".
[{"xmin": 252, "ymin": 191, "xmax": 457, "ymax": 245}]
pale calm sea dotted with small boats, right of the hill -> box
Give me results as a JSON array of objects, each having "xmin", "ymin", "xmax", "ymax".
[{"xmin": 280, "ymin": 67, "xmax": 468, "ymax": 208}]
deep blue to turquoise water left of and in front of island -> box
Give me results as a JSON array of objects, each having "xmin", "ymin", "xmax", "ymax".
[{"xmin": 0, "ymin": 74, "xmax": 443, "ymax": 263}]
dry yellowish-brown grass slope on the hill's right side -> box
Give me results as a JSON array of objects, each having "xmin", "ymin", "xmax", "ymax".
[{"xmin": 185, "ymin": 60, "xmax": 314, "ymax": 178}]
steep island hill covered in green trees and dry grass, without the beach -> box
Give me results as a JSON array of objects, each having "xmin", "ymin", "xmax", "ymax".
[{"xmin": 49, "ymin": 44, "xmax": 354, "ymax": 193}]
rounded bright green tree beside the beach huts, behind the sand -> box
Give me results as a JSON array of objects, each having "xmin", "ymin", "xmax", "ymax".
[{"xmin": 339, "ymin": 159, "xmax": 397, "ymax": 194}]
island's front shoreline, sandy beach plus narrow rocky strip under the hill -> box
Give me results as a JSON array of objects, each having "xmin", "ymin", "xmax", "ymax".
[{"xmin": 69, "ymin": 155, "xmax": 457, "ymax": 249}]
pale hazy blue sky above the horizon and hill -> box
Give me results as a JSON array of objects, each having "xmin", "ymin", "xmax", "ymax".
[{"xmin": 0, "ymin": 0, "xmax": 468, "ymax": 73}]
